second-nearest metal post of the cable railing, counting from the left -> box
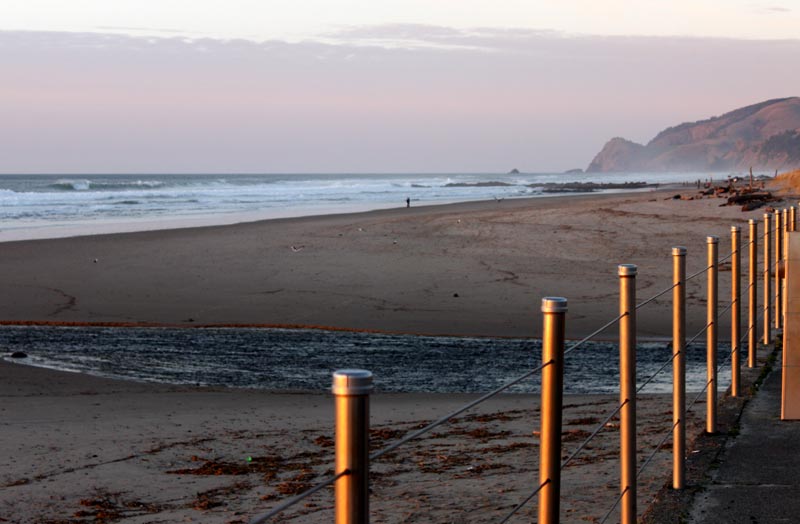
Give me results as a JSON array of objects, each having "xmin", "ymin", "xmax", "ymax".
[{"xmin": 538, "ymin": 297, "xmax": 567, "ymax": 524}]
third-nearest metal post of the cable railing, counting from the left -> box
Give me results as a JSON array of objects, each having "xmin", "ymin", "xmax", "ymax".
[{"xmin": 617, "ymin": 264, "xmax": 637, "ymax": 524}]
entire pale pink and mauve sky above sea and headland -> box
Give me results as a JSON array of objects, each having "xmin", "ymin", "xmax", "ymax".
[{"xmin": 0, "ymin": 0, "xmax": 800, "ymax": 174}]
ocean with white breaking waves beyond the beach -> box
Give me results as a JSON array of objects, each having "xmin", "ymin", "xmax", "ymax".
[{"xmin": 0, "ymin": 173, "xmax": 706, "ymax": 241}]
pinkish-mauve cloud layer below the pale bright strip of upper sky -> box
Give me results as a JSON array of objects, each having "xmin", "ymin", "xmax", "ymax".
[{"xmin": 0, "ymin": 26, "xmax": 800, "ymax": 173}]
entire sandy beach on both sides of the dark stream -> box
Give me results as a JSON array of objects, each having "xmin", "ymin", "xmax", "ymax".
[{"xmin": 0, "ymin": 188, "xmax": 776, "ymax": 524}]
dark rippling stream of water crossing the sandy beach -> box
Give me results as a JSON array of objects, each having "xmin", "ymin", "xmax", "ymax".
[{"xmin": 0, "ymin": 326, "xmax": 730, "ymax": 394}]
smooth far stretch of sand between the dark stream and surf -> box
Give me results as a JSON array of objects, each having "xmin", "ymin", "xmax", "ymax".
[{"xmin": 0, "ymin": 188, "xmax": 763, "ymax": 338}]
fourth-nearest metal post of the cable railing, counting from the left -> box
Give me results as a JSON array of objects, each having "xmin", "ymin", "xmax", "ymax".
[{"xmin": 672, "ymin": 246, "xmax": 686, "ymax": 489}]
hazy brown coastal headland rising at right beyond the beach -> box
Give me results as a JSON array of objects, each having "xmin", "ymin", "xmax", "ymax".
[{"xmin": 586, "ymin": 97, "xmax": 800, "ymax": 172}]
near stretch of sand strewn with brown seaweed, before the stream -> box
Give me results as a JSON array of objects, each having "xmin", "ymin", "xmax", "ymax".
[{"xmin": 0, "ymin": 362, "xmax": 702, "ymax": 524}]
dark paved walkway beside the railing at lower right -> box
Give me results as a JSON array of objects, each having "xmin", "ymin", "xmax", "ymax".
[{"xmin": 689, "ymin": 355, "xmax": 800, "ymax": 524}]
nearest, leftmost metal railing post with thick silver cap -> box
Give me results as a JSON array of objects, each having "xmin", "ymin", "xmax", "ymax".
[{"xmin": 332, "ymin": 369, "xmax": 372, "ymax": 524}]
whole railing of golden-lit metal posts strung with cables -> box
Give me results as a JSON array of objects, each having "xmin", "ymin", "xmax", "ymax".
[{"xmin": 251, "ymin": 206, "xmax": 794, "ymax": 524}]
